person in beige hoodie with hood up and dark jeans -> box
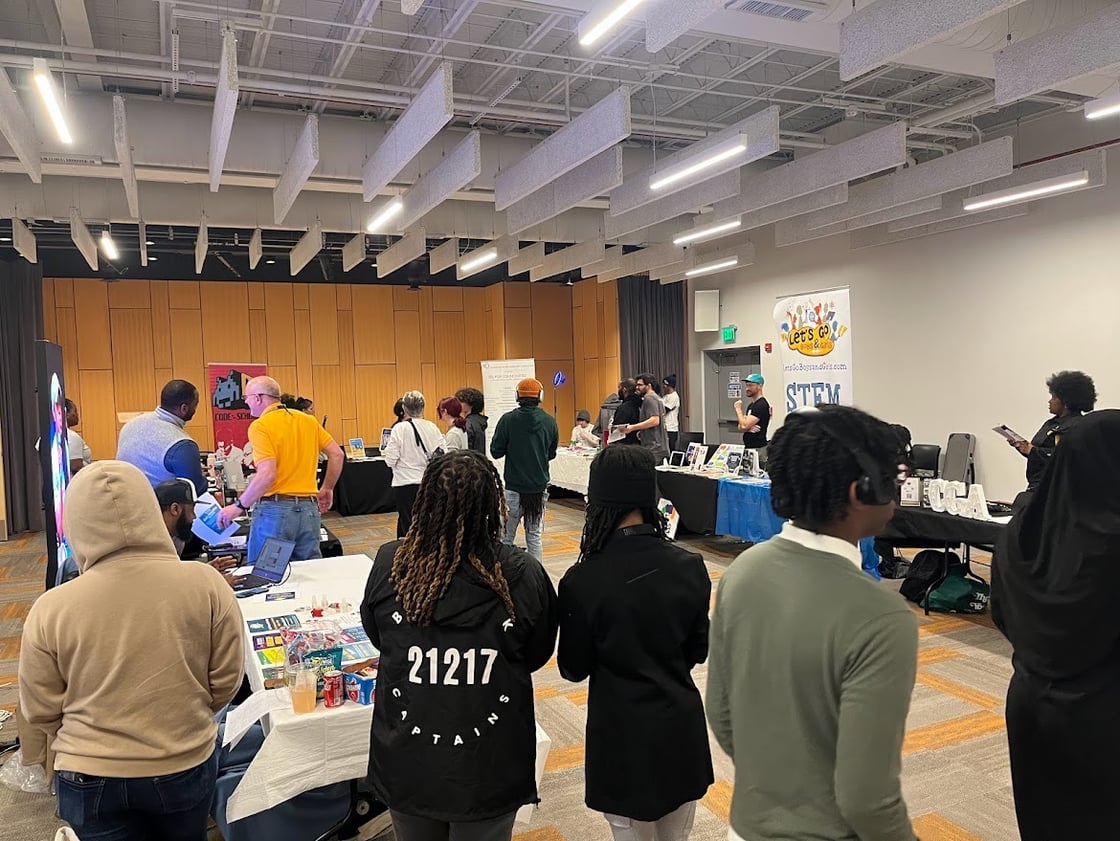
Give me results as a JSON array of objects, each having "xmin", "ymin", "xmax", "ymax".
[{"xmin": 19, "ymin": 461, "xmax": 244, "ymax": 841}]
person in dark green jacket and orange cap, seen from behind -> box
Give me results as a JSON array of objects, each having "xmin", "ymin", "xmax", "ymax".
[{"xmin": 491, "ymin": 376, "xmax": 560, "ymax": 561}]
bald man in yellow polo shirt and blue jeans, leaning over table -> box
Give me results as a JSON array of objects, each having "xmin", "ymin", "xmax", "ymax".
[{"xmin": 220, "ymin": 376, "xmax": 343, "ymax": 563}]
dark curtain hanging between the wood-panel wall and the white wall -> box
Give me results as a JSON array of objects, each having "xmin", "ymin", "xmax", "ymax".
[{"xmin": 618, "ymin": 277, "xmax": 685, "ymax": 391}]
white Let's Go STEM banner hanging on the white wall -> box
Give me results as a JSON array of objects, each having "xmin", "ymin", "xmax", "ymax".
[{"xmin": 774, "ymin": 287, "xmax": 852, "ymax": 412}]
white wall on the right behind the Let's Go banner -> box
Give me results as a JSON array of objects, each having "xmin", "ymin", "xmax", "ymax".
[{"xmin": 688, "ymin": 128, "xmax": 1120, "ymax": 499}]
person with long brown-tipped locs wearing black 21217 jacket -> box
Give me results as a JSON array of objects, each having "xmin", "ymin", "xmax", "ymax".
[{"xmin": 362, "ymin": 450, "xmax": 558, "ymax": 841}]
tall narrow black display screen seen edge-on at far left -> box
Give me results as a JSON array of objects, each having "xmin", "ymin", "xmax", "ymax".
[{"xmin": 35, "ymin": 340, "xmax": 74, "ymax": 589}]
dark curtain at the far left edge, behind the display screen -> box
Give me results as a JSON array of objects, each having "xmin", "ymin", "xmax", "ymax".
[{"xmin": 0, "ymin": 259, "xmax": 43, "ymax": 534}]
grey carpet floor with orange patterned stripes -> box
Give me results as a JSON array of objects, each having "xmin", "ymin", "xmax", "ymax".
[{"xmin": 0, "ymin": 501, "xmax": 1019, "ymax": 841}]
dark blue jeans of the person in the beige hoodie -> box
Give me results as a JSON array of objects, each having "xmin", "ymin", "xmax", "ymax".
[{"xmin": 57, "ymin": 750, "xmax": 217, "ymax": 841}]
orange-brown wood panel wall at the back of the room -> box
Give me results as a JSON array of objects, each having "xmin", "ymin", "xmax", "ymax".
[{"xmin": 43, "ymin": 278, "xmax": 618, "ymax": 458}]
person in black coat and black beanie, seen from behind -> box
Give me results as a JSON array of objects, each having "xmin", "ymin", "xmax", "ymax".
[{"xmin": 557, "ymin": 447, "xmax": 715, "ymax": 841}]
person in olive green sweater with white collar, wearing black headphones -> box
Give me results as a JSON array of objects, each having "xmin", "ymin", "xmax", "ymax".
[{"xmin": 707, "ymin": 405, "xmax": 917, "ymax": 841}]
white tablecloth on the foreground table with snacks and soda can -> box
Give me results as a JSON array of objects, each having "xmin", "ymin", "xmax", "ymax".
[{"xmin": 226, "ymin": 554, "xmax": 552, "ymax": 822}]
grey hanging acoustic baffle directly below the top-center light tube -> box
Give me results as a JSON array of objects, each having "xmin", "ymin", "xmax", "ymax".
[{"xmin": 494, "ymin": 86, "xmax": 631, "ymax": 211}]
